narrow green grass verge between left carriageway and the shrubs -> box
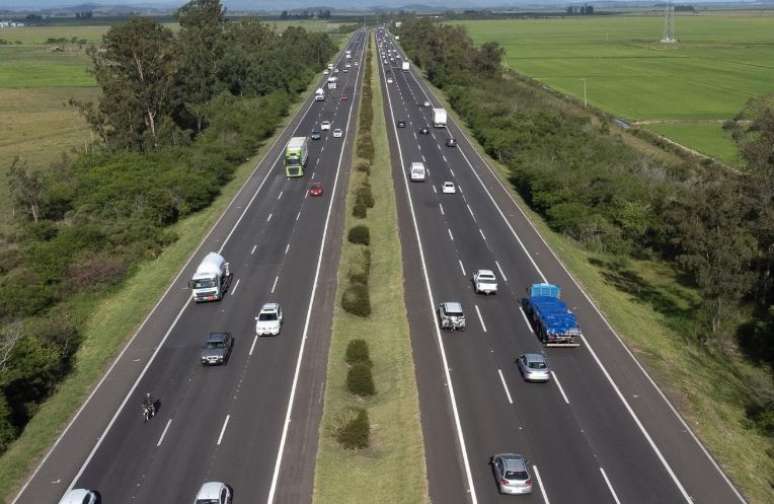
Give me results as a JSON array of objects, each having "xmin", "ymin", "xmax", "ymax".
[{"xmin": 0, "ymin": 72, "xmax": 319, "ymax": 502}]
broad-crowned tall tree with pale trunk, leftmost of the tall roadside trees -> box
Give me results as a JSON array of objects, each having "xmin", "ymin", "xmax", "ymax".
[{"xmin": 87, "ymin": 18, "xmax": 177, "ymax": 150}]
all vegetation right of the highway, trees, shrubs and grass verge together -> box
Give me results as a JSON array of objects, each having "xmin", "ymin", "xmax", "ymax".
[{"xmin": 398, "ymin": 18, "xmax": 774, "ymax": 503}]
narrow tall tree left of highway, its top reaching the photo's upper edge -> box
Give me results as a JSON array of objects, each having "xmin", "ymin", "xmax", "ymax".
[{"xmin": 177, "ymin": 0, "xmax": 226, "ymax": 132}]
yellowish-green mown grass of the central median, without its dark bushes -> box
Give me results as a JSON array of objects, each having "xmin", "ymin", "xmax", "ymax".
[{"xmin": 314, "ymin": 33, "xmax": 429, "ymax": 504}]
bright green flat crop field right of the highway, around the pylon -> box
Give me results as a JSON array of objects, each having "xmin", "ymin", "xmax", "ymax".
[{"xmin": 462, "ymin": 11, "xmax": 774, "ymax": 164}]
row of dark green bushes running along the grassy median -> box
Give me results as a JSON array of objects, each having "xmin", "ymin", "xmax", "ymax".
[{"xmin": 336, "ymin": 39, "xmax": 376, "ymax": 450}]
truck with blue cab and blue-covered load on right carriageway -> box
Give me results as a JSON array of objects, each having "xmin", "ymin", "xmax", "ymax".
[{"xmin": 523, "ymin": 283, "xmax": 581, "ymax": 347}]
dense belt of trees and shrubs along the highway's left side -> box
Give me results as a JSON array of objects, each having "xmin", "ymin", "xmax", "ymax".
[{"xmin": 0, "ymin": 0, "xmax": 336, "ymax": 453}]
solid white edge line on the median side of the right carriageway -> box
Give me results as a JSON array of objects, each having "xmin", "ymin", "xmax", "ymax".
[{"xmin": 379, "ymin": 39, "xmax": 478, "ymax": 504}]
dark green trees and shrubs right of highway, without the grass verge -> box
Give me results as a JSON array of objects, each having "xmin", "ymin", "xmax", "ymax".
[{"xmin": 397, "ymin": 17, "xmax": 774, "ymax": 435}]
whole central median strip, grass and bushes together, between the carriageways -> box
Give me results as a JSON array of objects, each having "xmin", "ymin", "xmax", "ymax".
[{"xmin": 314, "ymin": 32, "xmax": 429, "ymax": 504}]
